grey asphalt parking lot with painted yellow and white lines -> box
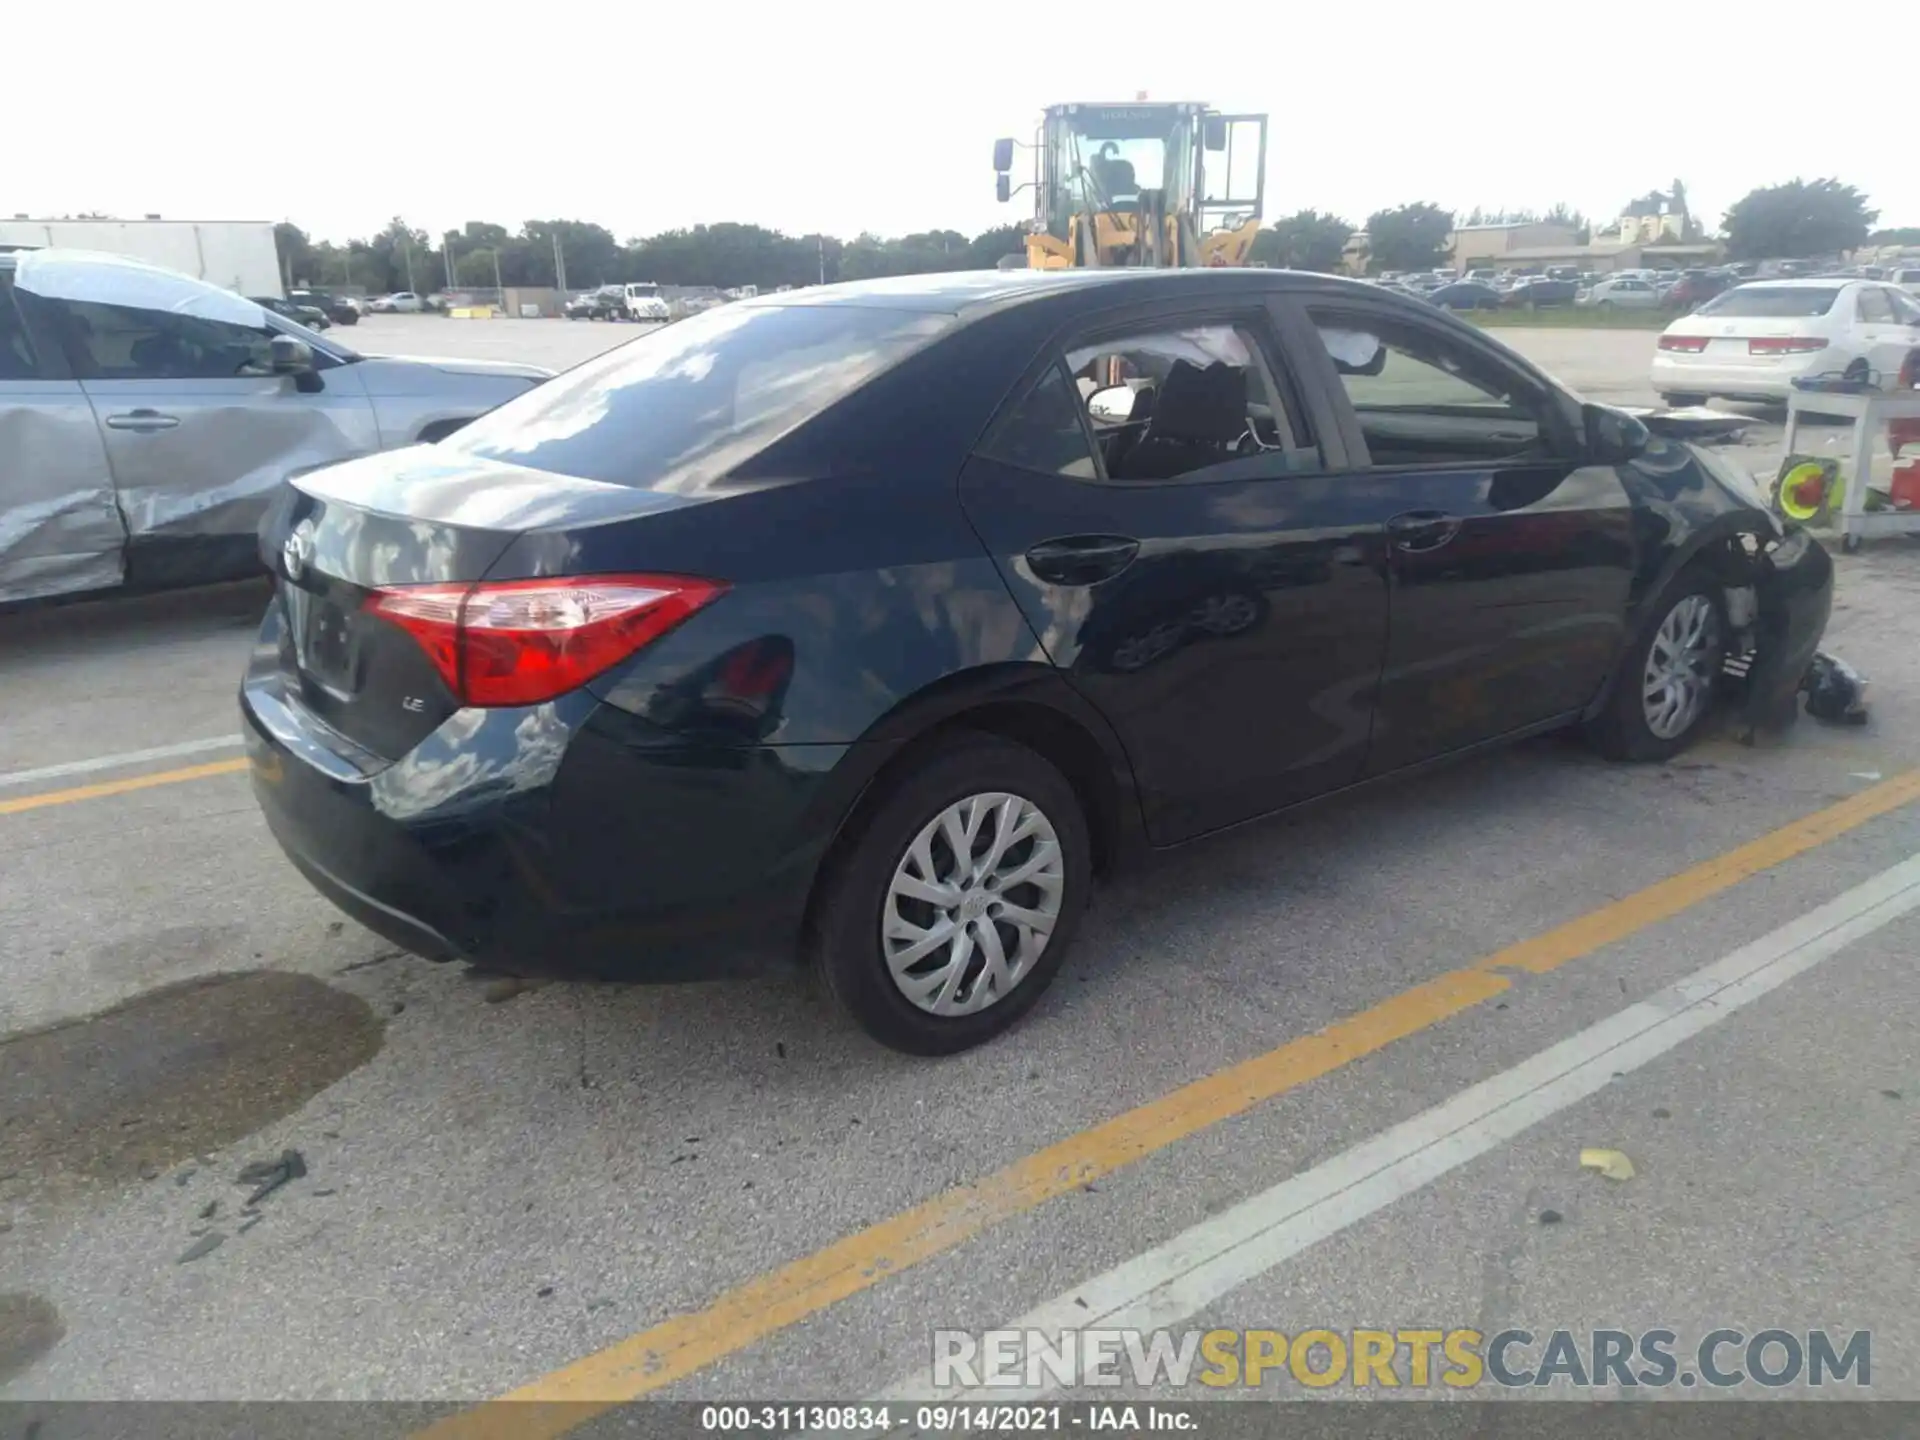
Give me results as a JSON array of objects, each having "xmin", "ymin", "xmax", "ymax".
[{"xmin": 0, "ymin": 317, "xmax": 1920, "ymax": 1432}]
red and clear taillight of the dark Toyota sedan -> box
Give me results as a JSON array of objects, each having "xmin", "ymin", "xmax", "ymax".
[{"xmin": 363, "ymin": 574, "xmax": 726, "ymax": 705}]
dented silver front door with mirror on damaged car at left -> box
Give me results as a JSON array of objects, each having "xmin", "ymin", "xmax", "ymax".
[{"xmin": 44, "ymin": 284, "xmax": 380, "ymax": 584}]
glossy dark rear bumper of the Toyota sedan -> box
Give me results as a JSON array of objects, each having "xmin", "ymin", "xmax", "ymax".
[{"xmin": 240, "ymin": 664, "xmax": 845, "ymax": 981}]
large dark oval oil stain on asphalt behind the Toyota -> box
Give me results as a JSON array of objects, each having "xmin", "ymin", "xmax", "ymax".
[{"xmin": 0, "ymin": 970, "xmax": 384, "ymax": 1192}]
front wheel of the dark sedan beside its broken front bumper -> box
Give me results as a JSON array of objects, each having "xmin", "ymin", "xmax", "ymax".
[{"xmin": 1586, "ymin": 566, "xmax": 1728, "ymax": 760}]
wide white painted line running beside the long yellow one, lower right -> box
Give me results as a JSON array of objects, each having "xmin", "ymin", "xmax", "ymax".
[{"xmin": 881, "ymin": 854, "xmax": 1920, "ymax": 1404}]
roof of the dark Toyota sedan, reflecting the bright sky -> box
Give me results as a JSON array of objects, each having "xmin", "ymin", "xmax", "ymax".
[{"xmin": 733, "ymin": 267, "xmax": 1379, "ymax": 315}]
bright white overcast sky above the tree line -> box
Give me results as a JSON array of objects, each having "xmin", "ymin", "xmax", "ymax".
[{"xmin": 11, "ymin": 0, "xmax": 1920, "ymax": 240}]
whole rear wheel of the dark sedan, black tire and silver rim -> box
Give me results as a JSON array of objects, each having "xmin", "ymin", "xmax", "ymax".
[{"xmin": 810, "ymin": 733, "xmax": 1092, "ymax": 1056}]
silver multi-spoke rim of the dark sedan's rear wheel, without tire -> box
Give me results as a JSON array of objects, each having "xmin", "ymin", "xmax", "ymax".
[{"xmin": 879, "ymin": 791, "xmax": 1066, "ymax": 1016}]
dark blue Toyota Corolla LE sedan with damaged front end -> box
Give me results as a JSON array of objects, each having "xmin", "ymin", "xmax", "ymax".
[{"xmin": 240, "ymin": 271, "xmax": 1832, "ymax": 1054}]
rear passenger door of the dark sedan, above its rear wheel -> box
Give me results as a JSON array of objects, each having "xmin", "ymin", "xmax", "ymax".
[{"xmin": 960, "ymin": 298, "xmax": 1394, "ymax": 845}]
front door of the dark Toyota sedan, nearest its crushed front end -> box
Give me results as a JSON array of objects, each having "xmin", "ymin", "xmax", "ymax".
[{"xmin": 1308, "ymin": 301, "xmax": 1634, "ymax": 774}]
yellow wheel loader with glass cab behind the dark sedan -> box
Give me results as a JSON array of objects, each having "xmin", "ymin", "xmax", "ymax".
[{"xmin": 993, "ymin": 100, "xmax": 1267, "ymax": 271}]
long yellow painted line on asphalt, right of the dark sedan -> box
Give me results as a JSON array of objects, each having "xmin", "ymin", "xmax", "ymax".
[{"xmin": 420, "ymin": 772, "xmax": 1920, "ymax": 1440}]
